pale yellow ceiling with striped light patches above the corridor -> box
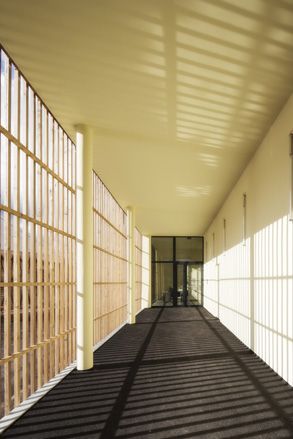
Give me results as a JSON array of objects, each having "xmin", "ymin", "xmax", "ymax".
[{"xmin": 0, "ymin": 0, "xmax": 293, "ymax": 235}]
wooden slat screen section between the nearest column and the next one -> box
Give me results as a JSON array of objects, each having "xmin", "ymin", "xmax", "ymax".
[{"xmin": 93, "ymin": 172, "xmax": 127, "ymax": 344}]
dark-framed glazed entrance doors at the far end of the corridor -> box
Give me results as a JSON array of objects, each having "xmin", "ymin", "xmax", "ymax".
[{"xmin": 152, "ymin": 236, "xmax": 203, "ymax": 306}]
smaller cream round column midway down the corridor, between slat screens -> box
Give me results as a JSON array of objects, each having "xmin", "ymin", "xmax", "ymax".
[{"xmin": 127, "ymin": 207, "xmax": 136, "ymax": 323}]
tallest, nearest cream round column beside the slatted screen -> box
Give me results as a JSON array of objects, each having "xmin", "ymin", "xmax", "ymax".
[{"xmin": 76, "ymin": 125, "xmax": 93, "ymax": 370}]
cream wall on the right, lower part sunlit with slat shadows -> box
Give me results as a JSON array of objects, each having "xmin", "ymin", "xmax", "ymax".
[{"xmin": 204, "ymin": 95, "xmax": 293, "ymax": 385}]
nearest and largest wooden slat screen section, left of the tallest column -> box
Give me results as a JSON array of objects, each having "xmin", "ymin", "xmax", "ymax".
[{"xmin": 0, "ymin": 47, "xmax": 76, "ymax": 416}]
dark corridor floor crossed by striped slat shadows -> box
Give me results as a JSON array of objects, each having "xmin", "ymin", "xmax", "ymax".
[{"xmin": 3, "ymin": 307, "xmax": 293, "ymax": 439}]
